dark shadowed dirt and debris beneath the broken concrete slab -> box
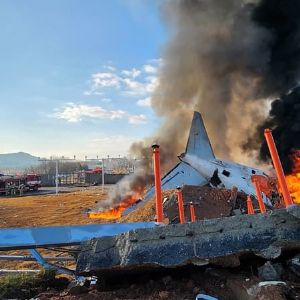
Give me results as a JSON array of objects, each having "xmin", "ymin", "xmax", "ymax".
[{"xmin": 28, "ymin": 261, "xmax": 299, "ymax": 300}]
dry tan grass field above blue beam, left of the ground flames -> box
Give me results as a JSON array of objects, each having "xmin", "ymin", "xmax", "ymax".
[{"xmin": 0, "ymin": 186, "xmax": 111, "ymax": 228}]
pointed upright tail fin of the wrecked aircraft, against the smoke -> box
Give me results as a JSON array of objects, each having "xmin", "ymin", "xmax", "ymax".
[{"xmin": 185, "ymin": 111, "xmax": 215, "ymax": 159}]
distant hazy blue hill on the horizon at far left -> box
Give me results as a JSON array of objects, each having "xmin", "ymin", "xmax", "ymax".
[{"xmin": 0, "ymin": 152, "xmax": 39, "ymax": 173}]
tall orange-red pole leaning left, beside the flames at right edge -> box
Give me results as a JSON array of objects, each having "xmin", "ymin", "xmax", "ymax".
[{"xmin": 265, "ymin": 129, "xmax": 294, "ymax": 207}]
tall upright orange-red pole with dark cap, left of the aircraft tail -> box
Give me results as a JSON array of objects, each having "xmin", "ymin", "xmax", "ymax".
[{"xmin": 152, "ymin": 144, "xmax": 163, "ymax": 223}]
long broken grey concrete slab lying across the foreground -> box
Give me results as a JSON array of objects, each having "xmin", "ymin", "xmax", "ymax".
[{"xmin": 77, "ymin": 206, "xmax": 300, "ymax": 275}]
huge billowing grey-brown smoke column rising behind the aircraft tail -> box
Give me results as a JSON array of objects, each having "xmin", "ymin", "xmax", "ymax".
[{"xmin": 100, "ymin": 0, "xmax": 300, "ymax": 211}]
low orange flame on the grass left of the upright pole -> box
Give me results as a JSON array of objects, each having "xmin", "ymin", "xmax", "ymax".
[{"xmin": 89, "ymin": 193, "xmax": 141, "ymax": 220}]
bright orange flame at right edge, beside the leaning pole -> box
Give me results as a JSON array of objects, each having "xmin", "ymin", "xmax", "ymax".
[{"xmin": 285, "ymin": 150, "xmax": 300, "ymax": 204}]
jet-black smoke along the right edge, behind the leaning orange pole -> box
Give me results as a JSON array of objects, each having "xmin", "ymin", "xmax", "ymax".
[{"xmin": 244, "ymin": 0, "xmax": 300, "ymax": 173}]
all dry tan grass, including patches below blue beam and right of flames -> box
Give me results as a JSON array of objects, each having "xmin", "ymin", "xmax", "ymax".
[{"xmin": 0, "ymin": 186, "xmax": 171, "ymax": 269}]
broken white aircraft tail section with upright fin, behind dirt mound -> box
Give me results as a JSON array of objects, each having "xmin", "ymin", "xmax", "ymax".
[{"xmin": 123, "ymin": 111, "xmax": 271, "ymax": 215}]
